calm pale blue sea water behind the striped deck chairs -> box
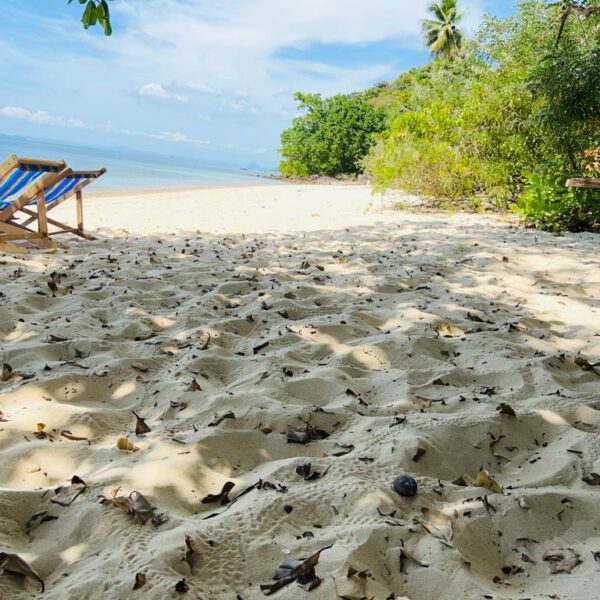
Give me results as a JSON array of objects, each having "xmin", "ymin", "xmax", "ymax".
[{"xmin": 0, "ymin": 136, "xmax": 274, "ymax": 191}]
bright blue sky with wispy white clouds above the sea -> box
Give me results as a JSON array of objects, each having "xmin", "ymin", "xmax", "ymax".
[{"xmin": 0, "ymin": 0, "xmax": 513, "ymax": 166}]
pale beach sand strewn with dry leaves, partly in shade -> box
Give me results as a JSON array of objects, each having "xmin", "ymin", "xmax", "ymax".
[{"xmin": 0, "ymin": 186, "xmax": 600, "ymax": 600}]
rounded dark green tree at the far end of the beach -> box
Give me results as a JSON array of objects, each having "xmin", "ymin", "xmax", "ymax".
[{"xmin": 279, "ymin": 93, "xmax": 385, "ymax": 177}]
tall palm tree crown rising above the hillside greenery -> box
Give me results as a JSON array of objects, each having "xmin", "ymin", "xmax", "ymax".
[{"xmin": 423, "ymin": 0, "xmax": 465, "ymax": 60}]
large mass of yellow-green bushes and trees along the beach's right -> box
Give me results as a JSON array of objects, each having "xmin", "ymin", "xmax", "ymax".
[{"xmin": 364, "ymin": 0, "xmax": 600, "ymax": 229}]
